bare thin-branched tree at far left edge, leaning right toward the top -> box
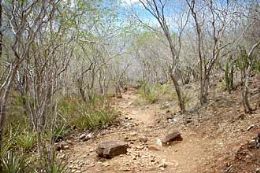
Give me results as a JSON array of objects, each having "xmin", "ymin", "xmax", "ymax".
[{"xmin": 0, "ymin": 0, "xmax": 59, "ymax": 159}]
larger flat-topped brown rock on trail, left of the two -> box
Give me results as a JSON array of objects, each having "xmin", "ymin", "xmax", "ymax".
[{"xmin": 96, "ymin": 141, "xmax": 129, "ymax": 159}]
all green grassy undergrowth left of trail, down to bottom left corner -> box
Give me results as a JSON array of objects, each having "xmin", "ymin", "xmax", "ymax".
[{"xmin": 0, "ymin": 96, "xmax": 117, "ymax": 173}]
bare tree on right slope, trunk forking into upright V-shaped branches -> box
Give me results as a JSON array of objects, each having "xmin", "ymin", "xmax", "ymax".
[{"xmin": 186, "ymin": 0, "xmax": 235, "ymax": 105}]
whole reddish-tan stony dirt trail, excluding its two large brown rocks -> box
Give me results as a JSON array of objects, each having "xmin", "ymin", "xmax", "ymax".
[{"xmin": 59, "ymin": 88, "xmax": 260, "ymax": 173}]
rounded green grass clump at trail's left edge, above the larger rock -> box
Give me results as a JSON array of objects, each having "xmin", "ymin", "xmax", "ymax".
[{"xmin": 59, "ymin": 97, "xmax": 117, "ymax": 130}]
